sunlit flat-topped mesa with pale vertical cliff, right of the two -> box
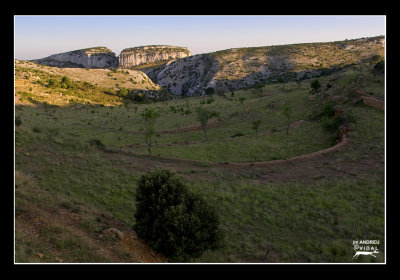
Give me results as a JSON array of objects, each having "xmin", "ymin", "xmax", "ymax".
[{"xmin": 118, "ymin": 45, "xmax": 192, "ymax": 68}]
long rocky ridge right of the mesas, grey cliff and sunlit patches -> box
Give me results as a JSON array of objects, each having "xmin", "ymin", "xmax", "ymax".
[{"xmin": 144, "ymin": 36, "xmax": 385, "ymax": 96}]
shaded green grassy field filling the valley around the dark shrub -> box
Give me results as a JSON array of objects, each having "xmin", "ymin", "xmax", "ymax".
[{"xmin": 15, "ymin": 62, "xmax": 385, "ymax": 263}]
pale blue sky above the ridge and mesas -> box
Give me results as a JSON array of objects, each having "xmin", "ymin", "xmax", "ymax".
[{"xmin": 14, "ymin": 15, "xmax": 386, "ymax": 59}]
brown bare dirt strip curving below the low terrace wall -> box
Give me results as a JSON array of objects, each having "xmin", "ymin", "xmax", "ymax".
[{"xmin": 104, "ymin": 135, "xmax": 384, "ymax": 183}]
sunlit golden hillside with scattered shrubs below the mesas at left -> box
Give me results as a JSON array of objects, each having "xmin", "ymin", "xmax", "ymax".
[{"xmin": 15, "ymin": 60, "xmax": 161, "ymax": 105}]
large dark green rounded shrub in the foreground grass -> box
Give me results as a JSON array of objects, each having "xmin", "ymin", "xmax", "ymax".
[{"xmin": 134, "ymin": 170, "xmax": 222, "ymax": 261}]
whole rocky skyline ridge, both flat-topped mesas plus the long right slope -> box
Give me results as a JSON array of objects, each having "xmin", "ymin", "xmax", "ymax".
[{"xmin": 28, "ymin": 36, "xmax": 385, "ymax": 96}]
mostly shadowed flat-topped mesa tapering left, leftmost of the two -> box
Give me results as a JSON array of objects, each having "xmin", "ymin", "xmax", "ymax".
[{"xmin": 33, "ymin": 47, "xmax": 118, "ymax": 68}]
